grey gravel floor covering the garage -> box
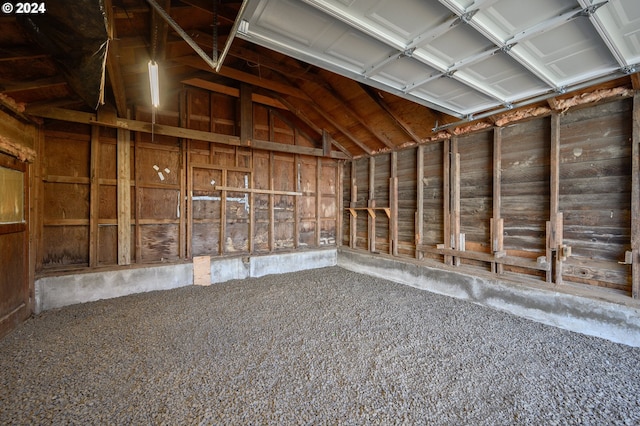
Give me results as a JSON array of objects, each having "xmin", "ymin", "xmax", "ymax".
[{"xmin": 0, "ymin": 267, "xmax": 640, "ymax": 425}]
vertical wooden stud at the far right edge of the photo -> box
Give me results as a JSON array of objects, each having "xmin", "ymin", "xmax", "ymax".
[{"xmin": 631, "ymin": 92, "xmax": 640, "ymax": 299}]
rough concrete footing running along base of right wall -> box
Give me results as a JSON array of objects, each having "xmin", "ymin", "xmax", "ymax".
[{"xmin": 338, "ymin": 250, "xmax": 640, "ymax": 347}]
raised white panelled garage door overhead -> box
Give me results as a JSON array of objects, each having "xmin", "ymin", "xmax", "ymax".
[{"xmin": 239, "ymin": 0, "xmax": 640, "ymax": 118}]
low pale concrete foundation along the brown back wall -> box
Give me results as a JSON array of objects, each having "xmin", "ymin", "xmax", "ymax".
[{"xmin": 35, "ymin": 249, "xmax": 337, "ymax": 313}]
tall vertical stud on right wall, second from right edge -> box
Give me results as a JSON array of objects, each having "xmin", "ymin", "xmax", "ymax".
[{"xmin": 546, "ymin": 113, "xmax": 562, "ymax": 284}]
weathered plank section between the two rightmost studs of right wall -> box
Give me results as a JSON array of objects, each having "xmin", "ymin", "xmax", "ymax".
[{"xmin": 559, "ymin": 100, "xmax": 632, "ymax": 292}]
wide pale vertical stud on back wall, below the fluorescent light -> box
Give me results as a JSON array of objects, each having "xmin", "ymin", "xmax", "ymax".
[{"xmin": 116, "ymin": 129, "xmax": 131, "ymax": 265}]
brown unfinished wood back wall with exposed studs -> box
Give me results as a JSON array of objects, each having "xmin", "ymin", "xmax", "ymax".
[{"xmin": 38, "ymin": 89, "xmax": 341, "ymax": 271}]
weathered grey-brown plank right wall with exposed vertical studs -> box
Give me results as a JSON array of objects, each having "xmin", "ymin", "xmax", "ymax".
[{"xmin": 342, "ymin": 98, "xmax": 638, "ymax": 295}]
